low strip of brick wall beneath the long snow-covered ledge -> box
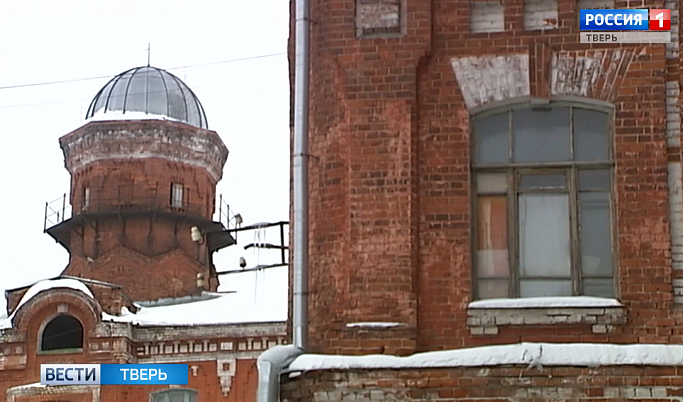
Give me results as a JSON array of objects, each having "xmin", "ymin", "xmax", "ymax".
[{"xmin": 282, "ymin": 366, "xmax": 683, "ymax": 402}]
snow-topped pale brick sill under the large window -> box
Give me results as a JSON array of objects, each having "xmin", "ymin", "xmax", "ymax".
[{"xmin": 467, "ymin": 297, "xmax": 626, "ymax": 335}]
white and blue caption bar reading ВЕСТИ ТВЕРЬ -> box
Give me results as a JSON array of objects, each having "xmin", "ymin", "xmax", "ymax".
[{"xmin": 40, "ymin": 364, "xmax": 188, "ymax": 385}]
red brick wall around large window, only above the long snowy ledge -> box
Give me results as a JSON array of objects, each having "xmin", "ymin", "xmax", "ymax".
[{"xmin": 292, "ymin": 0, "xmax": 683, "ymax": 354}]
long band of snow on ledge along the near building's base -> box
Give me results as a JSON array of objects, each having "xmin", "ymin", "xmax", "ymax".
[{"xmin": 287, "ymin": 343, "xmax": 683, "ymax": 372}]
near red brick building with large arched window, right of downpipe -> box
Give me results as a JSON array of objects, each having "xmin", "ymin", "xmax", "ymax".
[{"xmin": 283, "ymin": 0, "xmax": 683, "ymax": 401}]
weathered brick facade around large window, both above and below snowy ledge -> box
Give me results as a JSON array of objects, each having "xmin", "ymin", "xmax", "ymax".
[{"xmin": 283, "ymin": 0, "xmax": 683, "ymax": 401}]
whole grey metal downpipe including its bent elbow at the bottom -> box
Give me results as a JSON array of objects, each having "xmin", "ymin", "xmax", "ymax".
[{"xmin": 256, "ymin": 0, "xmax": 310, "ymax": 402}]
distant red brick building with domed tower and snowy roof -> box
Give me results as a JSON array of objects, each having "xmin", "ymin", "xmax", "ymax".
[{"xmin": 0, "ymin": 67, "xmax": 286, "ymax": 402}]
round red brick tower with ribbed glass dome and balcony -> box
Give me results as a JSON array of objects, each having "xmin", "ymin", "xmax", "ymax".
[{"xmin": 46, "ymin": 67, "xmax": 234, "ymax": 300}]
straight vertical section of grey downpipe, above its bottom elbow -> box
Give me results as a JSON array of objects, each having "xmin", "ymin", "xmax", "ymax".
[{"xmin": 292, "ymin": 0, "xmax": 309, "ymax": 350}]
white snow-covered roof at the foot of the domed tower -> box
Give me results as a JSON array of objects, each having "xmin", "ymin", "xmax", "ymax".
[{"xmin": 102, "ymin": 292, "xmax": 287, "ymax": 326}]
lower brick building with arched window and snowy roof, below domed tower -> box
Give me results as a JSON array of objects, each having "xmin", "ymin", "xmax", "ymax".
[{"xmin": 0, "ymin": 277, "xmax": 285, "ymax": 402}]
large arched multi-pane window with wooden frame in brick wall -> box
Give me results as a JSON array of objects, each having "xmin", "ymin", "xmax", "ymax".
[{"xmin": 473, "ymin": 104, "xmax": 615, "ymax": 299}]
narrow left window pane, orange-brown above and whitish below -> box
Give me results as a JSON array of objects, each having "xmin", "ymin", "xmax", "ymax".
[{"xmin": 477, "ymin": 195, "xmax": 510, "ymax": 278}]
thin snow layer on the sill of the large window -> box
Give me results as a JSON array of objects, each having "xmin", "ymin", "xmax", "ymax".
[{"xmin": 468, "ymin": 296, "xmax": 622, "ymax": 308}]
